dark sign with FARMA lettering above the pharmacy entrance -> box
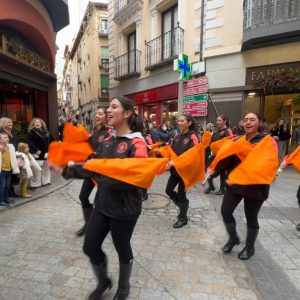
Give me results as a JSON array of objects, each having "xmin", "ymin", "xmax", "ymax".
[{"xmin": 246, "ymin": 62, "xmax": 300, "ymax": 85}]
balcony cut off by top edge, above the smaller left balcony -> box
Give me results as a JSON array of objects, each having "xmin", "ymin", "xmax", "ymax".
[{"xmin": 113, "ymin": 0, "xmax": 143, "ymax": 24}]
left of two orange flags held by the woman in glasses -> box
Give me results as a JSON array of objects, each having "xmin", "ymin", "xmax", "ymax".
[{"xmin": 209, "ymin": 136, "xmax": 255, "ymax": 170}]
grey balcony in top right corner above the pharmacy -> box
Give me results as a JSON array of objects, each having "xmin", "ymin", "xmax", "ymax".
[{"xmin": 242, "ymin": 0, "xmax": 300, "ymax": 50}]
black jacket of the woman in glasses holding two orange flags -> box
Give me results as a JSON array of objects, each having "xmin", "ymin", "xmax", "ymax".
[{"xmin": 214, "ymin": 133, "xmax": 270, "ymax": 201}]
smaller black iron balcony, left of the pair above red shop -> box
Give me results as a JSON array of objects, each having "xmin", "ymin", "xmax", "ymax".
[{"xmin": 114, "ymin": 49, "xmax": 141, "ymax": 81}]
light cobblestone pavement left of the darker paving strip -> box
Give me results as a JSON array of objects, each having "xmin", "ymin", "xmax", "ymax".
[{"xmin": 0, "ymin": 173, "xmax": 262, "ymax": 300}]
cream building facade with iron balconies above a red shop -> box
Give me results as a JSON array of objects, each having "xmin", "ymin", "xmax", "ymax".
[{"xmin": 109, "ymin": 0, "xmax": 201, "ymax": 124}]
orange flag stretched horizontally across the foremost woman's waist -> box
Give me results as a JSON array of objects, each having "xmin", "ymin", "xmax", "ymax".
[{"xmin": 83, "ymin": 158, "xmax": 168, "ymax": 189}]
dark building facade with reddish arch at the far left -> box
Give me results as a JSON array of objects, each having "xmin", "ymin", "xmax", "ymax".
[{"xmin": 0, "ymin": 0, "xmax": 69, "ymax": 136}]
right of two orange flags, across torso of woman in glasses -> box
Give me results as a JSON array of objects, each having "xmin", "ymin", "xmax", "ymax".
[{"xmin": 228, "ymin": 135, "xmax": 278, "ymax": 185}]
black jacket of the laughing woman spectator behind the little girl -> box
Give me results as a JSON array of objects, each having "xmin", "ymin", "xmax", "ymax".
[{"xmin": 27, "ymin": 128, "xmax": 53, "ymax": 160}]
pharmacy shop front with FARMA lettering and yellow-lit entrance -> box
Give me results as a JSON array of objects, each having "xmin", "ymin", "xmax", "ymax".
[{"xmin": 244, "ymin": 62, "xmax": 300, "ymax": 148}]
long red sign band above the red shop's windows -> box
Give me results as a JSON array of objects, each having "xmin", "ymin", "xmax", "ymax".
[{"xmin": 126, "ymin": 83, "xmax": 178, "ymax": 105}]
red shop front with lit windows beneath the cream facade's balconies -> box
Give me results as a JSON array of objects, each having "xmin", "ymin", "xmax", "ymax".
[{"xmin": 125, "ymin": 83, "xmax": 178, "ymax": 126}]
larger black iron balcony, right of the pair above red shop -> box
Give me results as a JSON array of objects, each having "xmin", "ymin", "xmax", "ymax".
[{"xmin": 145, "ymin": 26, "xmax": 184, "ymax": 71}]
